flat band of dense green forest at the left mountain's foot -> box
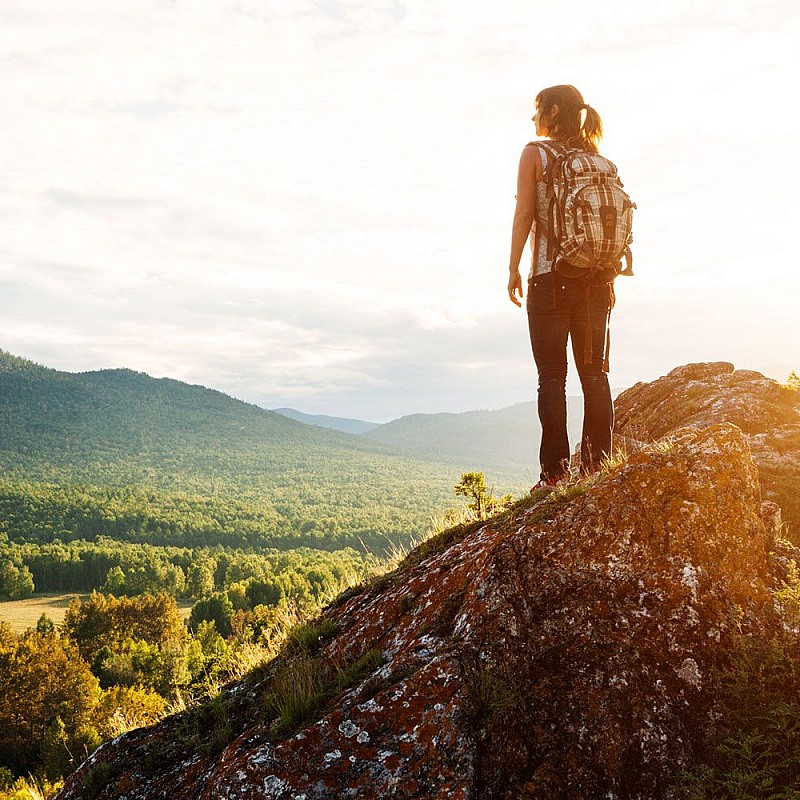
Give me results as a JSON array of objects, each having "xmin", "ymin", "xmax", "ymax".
[{"xmin": 0, "ymin": 477, "xmax": 450, "ymax": 551}]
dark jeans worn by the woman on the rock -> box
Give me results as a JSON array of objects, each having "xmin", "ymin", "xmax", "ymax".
[{"xmin": 527, "ymin": 273, "xmax": 614, "ymax": 479}]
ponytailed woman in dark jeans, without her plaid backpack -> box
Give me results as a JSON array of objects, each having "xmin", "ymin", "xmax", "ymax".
[{"xmin": 508, "ymin": 86, "xmax": 614, "ymax": 489}]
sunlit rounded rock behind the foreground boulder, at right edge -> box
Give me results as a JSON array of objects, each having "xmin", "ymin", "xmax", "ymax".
[{"xmin": 615, "ymin": 361, "xmax": 800, "ymax": 540}]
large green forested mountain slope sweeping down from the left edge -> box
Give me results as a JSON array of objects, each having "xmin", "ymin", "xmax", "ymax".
[{"xmin": 0, "ymin": 351, "xmax": 468, "ymax": 549}]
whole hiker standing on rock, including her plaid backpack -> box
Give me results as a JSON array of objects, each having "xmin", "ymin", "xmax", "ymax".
[{"xmin": 508, "ymin": 86, "xmax": 635, "ymax": 489}]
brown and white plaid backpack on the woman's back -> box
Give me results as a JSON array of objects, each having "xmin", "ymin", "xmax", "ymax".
[{"xmin": 536, "ymin": 141, "xmax": 636, "ymax": 283}]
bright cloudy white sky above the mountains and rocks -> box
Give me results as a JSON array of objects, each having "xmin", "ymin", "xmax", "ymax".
[{"xmin": 0, "ymin": 0, "xmax": 800, "ymax": 422}]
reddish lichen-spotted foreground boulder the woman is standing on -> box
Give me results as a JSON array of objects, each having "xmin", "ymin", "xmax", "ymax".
[{"xmin": 59, "ymin": 422, "xmax": 790, "ymax": 800}]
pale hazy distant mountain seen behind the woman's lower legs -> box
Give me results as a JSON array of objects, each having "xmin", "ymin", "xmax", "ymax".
[{"xmin": 361, "ymin": 397, "xmax": 583, "ymax": 485}]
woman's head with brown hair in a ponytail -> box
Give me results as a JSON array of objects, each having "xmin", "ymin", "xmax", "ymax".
[{"xmin": 533, "ymin": 85, "xmax": 603, "ymax": 152}]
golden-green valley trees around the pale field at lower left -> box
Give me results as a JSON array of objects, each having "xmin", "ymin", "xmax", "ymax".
[{"xmin": 0, "ymin": 538, "xmax": 381, "ymax": 788}]
